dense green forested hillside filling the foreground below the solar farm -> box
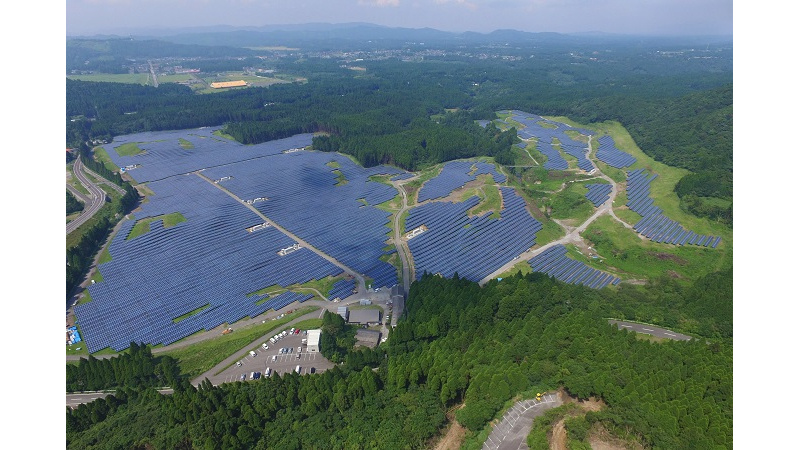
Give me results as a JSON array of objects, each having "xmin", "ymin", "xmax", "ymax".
[{"xmin": 67, "ymin": 273, "xmax": 733, "ymax": 449}]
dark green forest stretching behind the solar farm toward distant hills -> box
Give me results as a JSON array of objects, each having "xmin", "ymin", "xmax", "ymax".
[{"xmin": 66, "ymin": 34, "xmax": 733, "ymax": 207}]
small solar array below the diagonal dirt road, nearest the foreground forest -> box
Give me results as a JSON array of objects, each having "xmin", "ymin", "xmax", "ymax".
[{"xmin": 528, "ymin": 244, "xmax": 620, "ymax": 289}]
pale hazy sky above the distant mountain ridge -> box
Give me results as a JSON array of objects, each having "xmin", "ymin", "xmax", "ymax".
[{"xmin": 66, "ymin": 0, "xmax": 733, "ymax": 36}]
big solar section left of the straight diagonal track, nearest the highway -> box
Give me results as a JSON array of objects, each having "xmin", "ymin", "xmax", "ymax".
[{"xmin": 75, "ymin": 175, "xmax": 332, "ymax": 352}]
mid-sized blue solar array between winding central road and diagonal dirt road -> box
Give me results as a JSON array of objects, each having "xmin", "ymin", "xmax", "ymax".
[{"xmin": 404, "ymin": 187, "xmax": 542, "ymax": 281}]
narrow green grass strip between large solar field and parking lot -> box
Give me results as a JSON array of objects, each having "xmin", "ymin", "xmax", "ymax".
[{"xmin": 162, "ymin": 306, "xmax": 319, "ymax": 377}]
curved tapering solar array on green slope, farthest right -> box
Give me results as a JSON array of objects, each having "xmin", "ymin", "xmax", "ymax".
[{"xmin": 626, "ymin": 169, "xmax": 722, "ymax": 248}]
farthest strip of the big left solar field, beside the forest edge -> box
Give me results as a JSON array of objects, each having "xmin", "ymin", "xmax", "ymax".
[{"xmin": 98, "ymin": 128, "xmax": 313, "ymax": 183}]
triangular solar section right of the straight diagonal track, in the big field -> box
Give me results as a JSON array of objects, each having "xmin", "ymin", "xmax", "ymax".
[{"xmin": 203, "ymin": 151, "xmax": 404, "ymax": 287}]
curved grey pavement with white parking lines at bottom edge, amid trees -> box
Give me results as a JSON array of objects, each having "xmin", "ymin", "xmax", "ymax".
[{"xmin": 483, "ymin": 392, "xmax": 563, "ymax": 450}]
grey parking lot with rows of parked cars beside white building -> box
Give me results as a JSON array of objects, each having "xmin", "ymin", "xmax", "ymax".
[{"xmin": 210, "ymin": 331, "xmax": 333, "ymax": 384}]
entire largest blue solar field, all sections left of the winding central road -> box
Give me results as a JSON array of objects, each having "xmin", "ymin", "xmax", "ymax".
[{"xmin": 75, "ymin": 129, "xmax": 416, "ymax": 352}]
